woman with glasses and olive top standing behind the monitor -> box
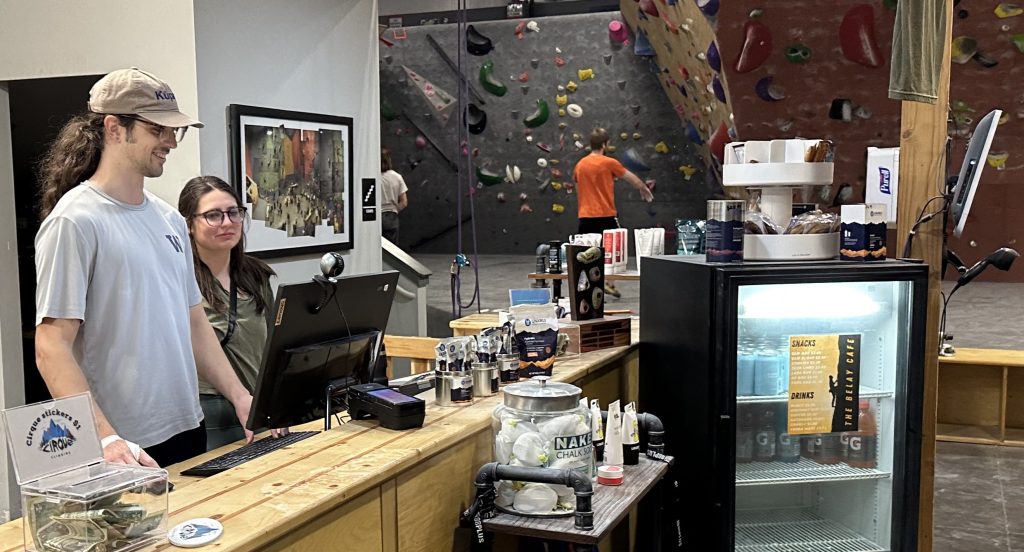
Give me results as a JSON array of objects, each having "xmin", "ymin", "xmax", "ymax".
[{"xmin": 178, "ymin": 176, "xmax": 288, "ymax": 451}]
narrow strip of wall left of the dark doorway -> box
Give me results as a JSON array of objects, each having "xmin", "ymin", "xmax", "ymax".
[{"xmin": 0, "ymin": 83, "xmax": 25, "ymax": 522}]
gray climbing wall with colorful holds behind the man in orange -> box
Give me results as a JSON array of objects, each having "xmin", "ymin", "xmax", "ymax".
[{"xmin": 380, "ymin": 12, "xmax": 719, "ymax": 254}]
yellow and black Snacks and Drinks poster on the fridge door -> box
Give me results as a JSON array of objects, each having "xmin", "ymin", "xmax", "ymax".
[{"xmin": 787, "ymin": 334, "xmax": 860, "ymax": 435}]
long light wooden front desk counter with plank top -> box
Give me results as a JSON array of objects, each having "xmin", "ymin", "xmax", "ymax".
[{"xmin": 0, "ymin": 342, "xmax": 639, "ymax": 552}]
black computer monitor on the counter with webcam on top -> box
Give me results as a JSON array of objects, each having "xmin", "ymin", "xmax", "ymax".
[{"xmin": 246, "ymin": 270, "xmax": 398, "ymax": 429}]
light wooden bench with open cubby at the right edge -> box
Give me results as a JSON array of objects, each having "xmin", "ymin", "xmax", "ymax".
[{"xmin": 935, "ymin": 347, "xmax": 1024, "ymax": 447}]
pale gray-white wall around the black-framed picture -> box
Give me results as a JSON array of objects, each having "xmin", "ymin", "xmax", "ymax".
[{"xmin": 196, "ymin": 0, "xmax": 381, "ymax": 282}]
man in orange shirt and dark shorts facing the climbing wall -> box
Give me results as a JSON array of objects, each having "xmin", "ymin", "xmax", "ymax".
[{"xmin": 572, "ymin": 128, "xmax": 654, "ymax": 297}]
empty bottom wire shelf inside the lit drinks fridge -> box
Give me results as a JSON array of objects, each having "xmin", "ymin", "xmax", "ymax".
[{"xmin": 735, "ymin": 509, "xmax": 886, "ymax": 552}]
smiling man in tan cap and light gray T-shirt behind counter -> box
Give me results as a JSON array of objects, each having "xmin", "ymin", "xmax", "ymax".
[{"xmin": 36, "ymin": 68, "xmax": 252, "ymax": 466}]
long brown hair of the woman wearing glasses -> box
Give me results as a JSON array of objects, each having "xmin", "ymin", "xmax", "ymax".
[{"xmin": 178, "ymin": 176, "xmax": 275, "ymax": 312}]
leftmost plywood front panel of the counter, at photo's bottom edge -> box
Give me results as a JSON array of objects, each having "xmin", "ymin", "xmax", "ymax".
[{"xmin": 263, "ymin": 490, "xmax": 383, "ymax": 552}]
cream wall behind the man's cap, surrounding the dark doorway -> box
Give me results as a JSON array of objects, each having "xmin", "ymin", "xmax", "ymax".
[{"xmin": 0, "ymin": 0, "xmax": 200, "ymax": 518}]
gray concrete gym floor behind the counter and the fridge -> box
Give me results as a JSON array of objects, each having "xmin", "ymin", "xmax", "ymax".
[{"xmin": 416, "ymin": 255, "xmax": 1024, "ymax": 552}]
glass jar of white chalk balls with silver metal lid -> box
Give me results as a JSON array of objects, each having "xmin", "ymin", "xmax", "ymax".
[{"xmin": 492, "ymin": 376, "xmax": 594, "ymax": 515}]
